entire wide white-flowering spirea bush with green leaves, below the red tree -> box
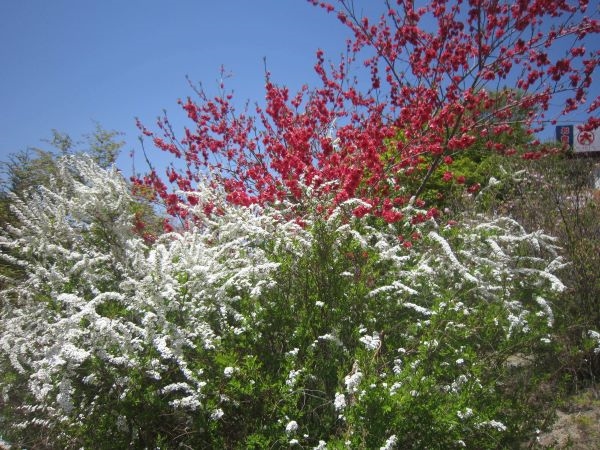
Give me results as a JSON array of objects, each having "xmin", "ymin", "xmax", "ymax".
[{"xmin": 0, "ymin": 158, "xmax": 563, "ymax": 449}]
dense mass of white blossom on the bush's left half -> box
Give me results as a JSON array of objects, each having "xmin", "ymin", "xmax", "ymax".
[{"xmin": 0, "ymin": 157, "xmax": 301, "ymax": 434}]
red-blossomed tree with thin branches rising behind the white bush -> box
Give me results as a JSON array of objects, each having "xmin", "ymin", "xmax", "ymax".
[{"xmin": 135, "ymin": 0, "xmax": 600, "ymax": 222}]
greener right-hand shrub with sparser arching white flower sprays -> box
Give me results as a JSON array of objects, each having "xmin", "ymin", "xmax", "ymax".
[{"xmin": 254, "ymin": 202, "xmax": 564, "ymax": 448}]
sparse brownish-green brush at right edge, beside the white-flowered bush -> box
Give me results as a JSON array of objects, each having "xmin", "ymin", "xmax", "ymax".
[{"xmin": 474, "ymin": 155, "xmax": 600, "ymax": 384}]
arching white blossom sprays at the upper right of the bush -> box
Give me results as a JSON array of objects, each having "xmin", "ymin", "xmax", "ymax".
[{"xmin": 365, "ymin": 217, "xmax": 565, "ymax": 338}]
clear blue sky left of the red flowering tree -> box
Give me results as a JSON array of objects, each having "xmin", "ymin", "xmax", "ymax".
[{"xmin": 0, "ymin": 0, "xmax": 598, "ymax": 179}]
